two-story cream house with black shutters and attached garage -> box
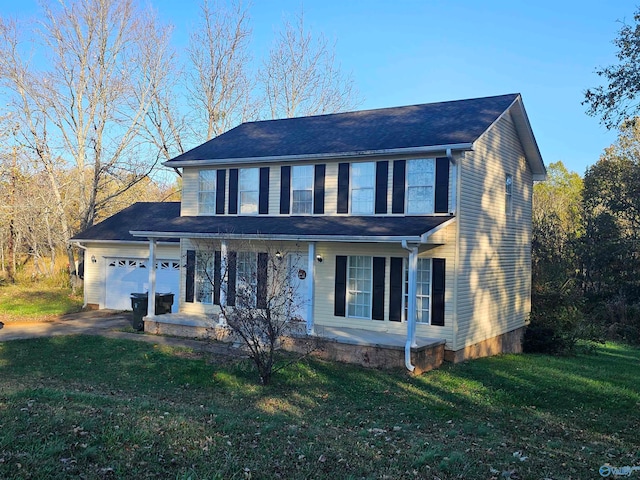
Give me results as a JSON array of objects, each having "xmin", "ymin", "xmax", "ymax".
[{"xmin": 73, "ymin": 94, "xmax": 546, "ymax": 369}]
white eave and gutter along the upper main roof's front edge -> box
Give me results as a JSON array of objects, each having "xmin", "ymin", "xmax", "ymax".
[{"xmin": 163, "ymin": 143, "xmax": 473, "ymax": 168}]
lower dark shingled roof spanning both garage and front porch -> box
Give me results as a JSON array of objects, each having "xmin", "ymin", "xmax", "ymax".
[{"xmin": 72, "ymin": 202, "xmax": 451, "ymax": 241}]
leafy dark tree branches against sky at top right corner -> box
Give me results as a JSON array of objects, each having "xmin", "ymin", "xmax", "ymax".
[{"xmin": 582, "ymin": 9, "xmax": 640, "ymax": 129}]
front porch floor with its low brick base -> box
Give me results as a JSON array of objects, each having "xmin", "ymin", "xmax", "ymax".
[{"xmin": 144, "ymin": 313, "xmax": 445, "ymax": 374}]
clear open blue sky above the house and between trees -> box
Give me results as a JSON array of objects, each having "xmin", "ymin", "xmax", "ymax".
[{"xmin": 0, "ymin": 0, "xmax": 636, "ymax": 175}]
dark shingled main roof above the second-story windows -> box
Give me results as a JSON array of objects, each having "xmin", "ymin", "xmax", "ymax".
[{"xmin": 165, "ymin": 94, "xmax": 519, "ymax": 167}]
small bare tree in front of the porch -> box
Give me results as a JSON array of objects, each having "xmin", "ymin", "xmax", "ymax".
[{"xmin": 196, "ymin": 241, "xmax": 316, "ymax": 385}]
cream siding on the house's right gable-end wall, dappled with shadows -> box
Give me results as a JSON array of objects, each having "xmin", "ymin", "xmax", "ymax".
[{"xmin": 452, "ymin": 111, "xmax": 533, "ymax": 350}]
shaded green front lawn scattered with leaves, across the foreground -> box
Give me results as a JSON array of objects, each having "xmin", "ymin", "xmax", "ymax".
[{"xmin": 0, "ymin": 336, "xmax": 640, "ymax": 480}]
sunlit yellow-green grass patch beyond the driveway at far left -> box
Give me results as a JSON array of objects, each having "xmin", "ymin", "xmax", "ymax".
[{"xmin": 0, "ymin": 282, "xmax": 83, "ymax": 321}]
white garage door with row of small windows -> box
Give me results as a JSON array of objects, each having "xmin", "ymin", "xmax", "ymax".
[{"xmin": 105, "ymin": 258, "xmax": 180, "ymax": 312}]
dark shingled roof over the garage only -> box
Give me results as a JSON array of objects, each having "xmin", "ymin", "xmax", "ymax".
[{"xmin": 71, "ymin": 202, "xmax": 180, "ymax": 242}]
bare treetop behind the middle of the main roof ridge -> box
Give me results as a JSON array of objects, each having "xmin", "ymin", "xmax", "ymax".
[{"xmin": 259, "ymin": 13, "xmax": 358, "ymax": 118}]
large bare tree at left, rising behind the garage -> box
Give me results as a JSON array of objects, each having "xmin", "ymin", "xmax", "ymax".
[{"xmin": 0, "ymin": 0, "xmax": 175, "ymax": 272}]
